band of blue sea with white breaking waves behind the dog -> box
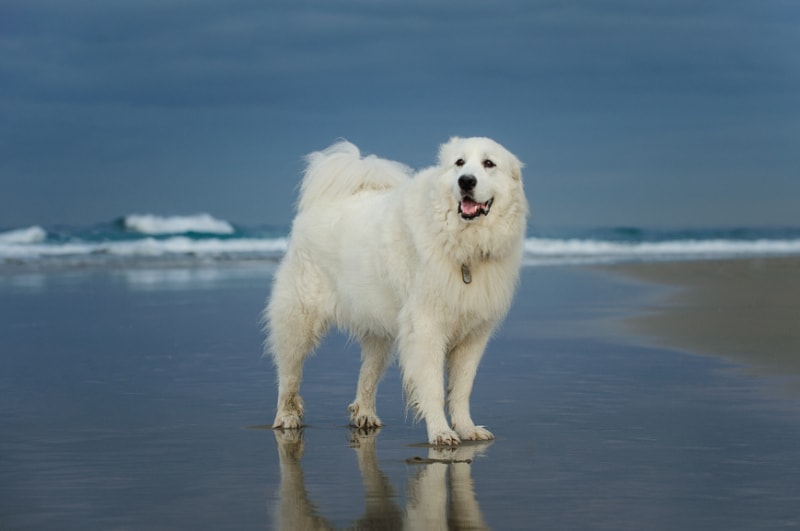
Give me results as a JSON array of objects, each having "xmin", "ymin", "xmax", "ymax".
[{"xmin": 0, "ymin": 214, "xmax": 800, "ymax": 270}]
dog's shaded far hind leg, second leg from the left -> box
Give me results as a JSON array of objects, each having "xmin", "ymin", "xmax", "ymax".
[{"xmin": 348, "ymin": 335, "xmax": 392, "ymax": 428}]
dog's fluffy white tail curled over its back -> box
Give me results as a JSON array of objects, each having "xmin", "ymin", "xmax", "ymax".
[{"xmin": 298, "ymin": 140, "xmax": 411, "ymax": 212}]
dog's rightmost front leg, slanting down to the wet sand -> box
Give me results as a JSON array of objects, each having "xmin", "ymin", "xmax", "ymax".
[{"xmin": 447, "ymin": 327, "xmax": 494, "ymax": 441}]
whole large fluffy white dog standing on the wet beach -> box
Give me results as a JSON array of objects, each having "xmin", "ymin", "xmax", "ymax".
[{"xmin": 264, "ymin": 138, "xmax": 528, "ymax": 445}]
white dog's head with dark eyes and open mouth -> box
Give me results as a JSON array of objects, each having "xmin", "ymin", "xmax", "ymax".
[{"xmin": 439, "ymin": 137, "xmax": 524, "ymax": 221}]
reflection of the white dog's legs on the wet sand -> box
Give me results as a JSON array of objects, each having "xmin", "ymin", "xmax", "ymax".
[{"xmin": 274, "ymin": 429, "xmax": 491, "ymax": 531}]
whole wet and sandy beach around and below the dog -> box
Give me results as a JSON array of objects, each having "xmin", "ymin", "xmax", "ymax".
[{"xmin": 0, "ymin": 258, "xmax": 800, "ymax": 530}]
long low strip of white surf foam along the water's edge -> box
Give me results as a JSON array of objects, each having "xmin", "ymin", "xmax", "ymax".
[{"xmin": 0, "ymin": 227, "xmax": 800, "ymax": 267}]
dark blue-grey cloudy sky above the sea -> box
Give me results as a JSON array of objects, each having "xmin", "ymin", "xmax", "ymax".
[{"xmin": 0, "ymin": 0, "xmax": 800, "ymax": 228}]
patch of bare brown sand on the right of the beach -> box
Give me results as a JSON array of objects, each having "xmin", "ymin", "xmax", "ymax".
[{"xmin": 596, "ymin": 257, "xmax": 800, "ymax": 390}]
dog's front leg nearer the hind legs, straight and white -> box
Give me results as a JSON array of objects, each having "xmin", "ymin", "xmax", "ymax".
[{"xmin": 398, "ymin": 312, "xmax": 461, "ymax": 446}]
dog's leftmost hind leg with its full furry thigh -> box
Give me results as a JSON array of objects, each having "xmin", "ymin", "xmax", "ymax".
[{"xmin": 265, "ymin": 257, "xmax": 330, "ymax": 428}]
